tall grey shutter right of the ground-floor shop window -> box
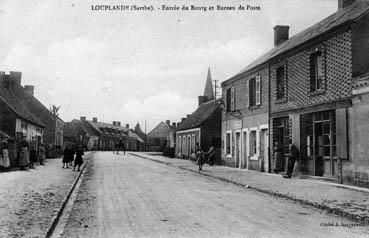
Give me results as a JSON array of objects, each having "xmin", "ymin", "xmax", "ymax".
[{"xmin": 336, "ymin": 108, "xmax": 347, "ymax": 159}]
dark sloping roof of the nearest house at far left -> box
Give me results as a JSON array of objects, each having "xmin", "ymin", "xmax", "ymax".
[{"xmin": 0, "ymin": 85, "xmax": 45, "ymax": 127}]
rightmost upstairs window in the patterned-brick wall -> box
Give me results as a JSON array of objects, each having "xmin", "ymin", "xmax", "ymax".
[{"xmin": 310, "ymin": 51, "xmax": 323, "ymax": 92}]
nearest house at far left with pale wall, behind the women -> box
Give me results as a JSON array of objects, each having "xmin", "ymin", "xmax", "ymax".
[{"xmin": 0, "ymin": 72, "xmax": 45, "ymax": 166}]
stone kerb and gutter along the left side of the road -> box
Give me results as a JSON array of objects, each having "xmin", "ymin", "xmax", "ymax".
[{"xmin": 45, "ymin": 151, "xmax": 95, "ymax": 238}]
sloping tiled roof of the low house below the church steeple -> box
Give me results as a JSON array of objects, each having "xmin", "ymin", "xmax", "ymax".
[{"xmin": 177, "ymin": 100, "xmax": 218, "ymax": 131}]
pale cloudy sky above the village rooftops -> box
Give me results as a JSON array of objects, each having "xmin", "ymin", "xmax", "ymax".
[{"xmin": 0, "ymin": 0, "xmax": 337, "ymax": 132}]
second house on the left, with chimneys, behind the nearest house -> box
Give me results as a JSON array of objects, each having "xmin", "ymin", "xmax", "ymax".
[{"xmin": 0, "ymin": 72, "xmax": 64, "ymax": 152}]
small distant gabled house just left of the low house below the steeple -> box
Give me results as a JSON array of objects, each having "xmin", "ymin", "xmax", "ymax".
[{"xmin": 146, "ymin": 120, "xmax": 172, "ymax": 152}]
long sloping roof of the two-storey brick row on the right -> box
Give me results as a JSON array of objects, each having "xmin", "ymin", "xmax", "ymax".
[{"xmin": 222, "ymin": 0, "xmax": 369, "ymax": 84}]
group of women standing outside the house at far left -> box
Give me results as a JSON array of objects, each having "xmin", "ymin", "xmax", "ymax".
[{"xmin": 0, "ymin": 136, "xmax": 46, "ymax": 171}]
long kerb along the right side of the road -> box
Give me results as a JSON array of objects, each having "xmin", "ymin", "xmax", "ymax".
[{"xmin": 129, "ymin": 153, "xmax": 369, "ymax": 225}]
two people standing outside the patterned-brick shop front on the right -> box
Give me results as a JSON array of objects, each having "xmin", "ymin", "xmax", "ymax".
[{"xmin": 273, "ymin": 140, "xmax": 299, "ymax": 178}]
